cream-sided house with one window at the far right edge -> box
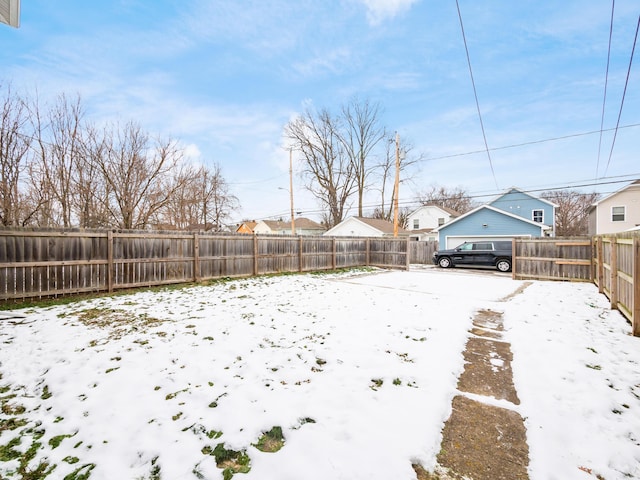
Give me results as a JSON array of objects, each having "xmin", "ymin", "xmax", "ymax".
[{"xmin": 589, "ymin": 180, "xmax": 640, "ymax": 235}]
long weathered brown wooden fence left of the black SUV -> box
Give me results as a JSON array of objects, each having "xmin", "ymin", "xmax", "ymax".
[{"xmin": 0, "ymin": 230, "xmax": 409, "ymax": 301}]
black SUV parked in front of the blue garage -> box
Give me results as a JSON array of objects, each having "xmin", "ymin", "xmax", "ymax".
[{"xmin": 433, "ymin": 240, "xmax": 512, "ymax": 272}]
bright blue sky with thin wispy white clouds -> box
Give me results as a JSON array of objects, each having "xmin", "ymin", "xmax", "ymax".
[{"xmin": 0, "ymin": 0, "xmax": 640, "ymax": 220}]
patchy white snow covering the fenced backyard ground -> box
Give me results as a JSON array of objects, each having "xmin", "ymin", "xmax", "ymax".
[{"xmin": 0, "ymin": 267, "xmax": 640, "ymax": 480}]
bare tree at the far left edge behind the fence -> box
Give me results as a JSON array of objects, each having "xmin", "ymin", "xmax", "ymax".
[{"xmin": 0, "ymin": 84, "xmax": 37, "ymax": 226}]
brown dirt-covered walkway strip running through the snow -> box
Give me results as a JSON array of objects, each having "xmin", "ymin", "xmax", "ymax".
[{"xmin": 414, "ymin": 310, "xmax": 529, "ymax": 480}]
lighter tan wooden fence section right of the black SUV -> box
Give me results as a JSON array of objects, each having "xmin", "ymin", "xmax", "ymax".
[{"xmin": 512, "ymin": 233, "xmax": 640, "ymax": 336}]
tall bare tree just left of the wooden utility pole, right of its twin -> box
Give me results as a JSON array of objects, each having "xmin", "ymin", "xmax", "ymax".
[{"xmin": 339, "ymin": 98, "xmax": 385, "ymax": 217}]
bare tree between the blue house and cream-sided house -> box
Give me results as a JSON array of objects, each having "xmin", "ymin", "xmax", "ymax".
[{"xmin": 540, "ymin": 190, "xmax": 599, "ymax": 237}]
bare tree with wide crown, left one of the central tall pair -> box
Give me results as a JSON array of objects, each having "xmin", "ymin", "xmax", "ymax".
[{"xmin": 285, "ymin": 110, "xmax": 358, "ymax": 227}]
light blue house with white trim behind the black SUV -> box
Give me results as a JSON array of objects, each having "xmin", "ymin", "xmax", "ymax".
[{"xmin": 436, "ymin": 188, "xmax": 556, "ymax": 248}]
